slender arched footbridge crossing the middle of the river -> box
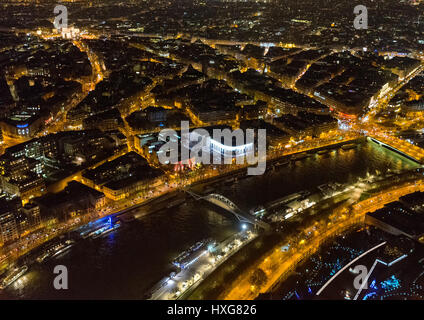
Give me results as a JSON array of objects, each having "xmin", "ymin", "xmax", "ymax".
[{"xmin": 185, "ymin": 190, "xmax": 270, "ymax": 230}]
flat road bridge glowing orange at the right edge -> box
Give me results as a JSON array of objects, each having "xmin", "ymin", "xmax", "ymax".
[{"xmin": 368, "ymin": 135, "xmax": 424, "ymax": 164}]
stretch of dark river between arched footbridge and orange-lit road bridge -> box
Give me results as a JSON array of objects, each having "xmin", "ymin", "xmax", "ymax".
[{"xmin": 220, "ymin": 142, "xmax": 417, "ymax": 210}]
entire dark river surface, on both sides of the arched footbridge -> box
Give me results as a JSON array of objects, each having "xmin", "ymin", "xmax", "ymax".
[{"xmin": 0, "ymin": 143, "xmax": 416, "ymax": 299}]
